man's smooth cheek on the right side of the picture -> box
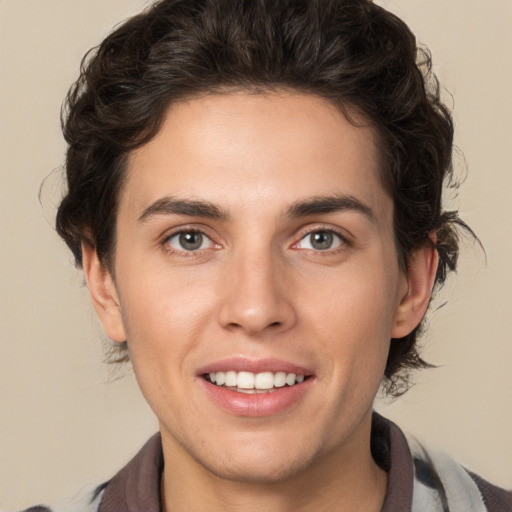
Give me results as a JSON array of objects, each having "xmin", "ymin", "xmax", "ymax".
[{"xmin": 309, "ymin": 264, "xmax": 399, "ymax": 380}]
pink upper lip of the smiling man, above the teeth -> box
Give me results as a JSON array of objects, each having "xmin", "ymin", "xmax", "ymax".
[{"xmin": 197, "ymin": 357, "xmax": 313, "ymax": 375}]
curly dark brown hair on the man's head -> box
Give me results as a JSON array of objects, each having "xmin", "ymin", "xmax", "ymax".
[{"xmin": 56, "ymin": 0, "xmax": 467, "ymax": 395}]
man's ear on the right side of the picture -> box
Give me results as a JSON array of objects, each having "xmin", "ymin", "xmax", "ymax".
[{"xmin": 391, "ymin": 240, "xmax": 439, "ymax": 338}]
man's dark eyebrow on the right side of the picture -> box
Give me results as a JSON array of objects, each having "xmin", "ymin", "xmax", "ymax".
[{"xmin": 286, "ymin": 194, "xmax": 377, "ymax": 224}]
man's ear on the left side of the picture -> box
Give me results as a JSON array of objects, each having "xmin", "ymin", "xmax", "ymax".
[{"xmin": 82, "ymin": 242, "xmax": 126, "ymax": 342}]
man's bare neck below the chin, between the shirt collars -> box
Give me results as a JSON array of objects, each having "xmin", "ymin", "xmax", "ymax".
[{"xmin": 161, "ymin": 412, "xmax": 387, "ymax": 512}]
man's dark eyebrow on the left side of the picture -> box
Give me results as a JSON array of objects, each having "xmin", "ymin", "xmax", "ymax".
[{"xmin": 138, "ymin": 196, "xmax": 229, "ymax": 222}]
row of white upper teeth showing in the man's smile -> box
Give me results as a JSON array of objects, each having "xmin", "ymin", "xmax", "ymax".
[{"xmin": 208, "ymin": 371, "xmax": 305, "ymax": 393}]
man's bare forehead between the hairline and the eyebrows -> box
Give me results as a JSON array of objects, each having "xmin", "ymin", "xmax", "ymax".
[{"xmin": 120, "ymin": 91, "xmax": 390, "ymax": 219}]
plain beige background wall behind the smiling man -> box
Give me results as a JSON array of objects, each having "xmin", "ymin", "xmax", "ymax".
[{"xmin": 0, "ymin": 0, "xmax": 512, "ymax": 510}]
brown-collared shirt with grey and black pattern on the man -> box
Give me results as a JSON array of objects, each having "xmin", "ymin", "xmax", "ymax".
[{"xmin": 25, "ymin": 413, "xmax": 512, "ymax": 512}]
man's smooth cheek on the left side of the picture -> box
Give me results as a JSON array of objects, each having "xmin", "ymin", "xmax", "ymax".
[{"xmin": 116, "ymin": 272, "xmax": 211, "ymax": 421}]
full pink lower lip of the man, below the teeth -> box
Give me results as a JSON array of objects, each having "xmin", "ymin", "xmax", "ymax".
[{"xmin": 199, "ymin": 377, "xmax": 314, "ymax": 417}]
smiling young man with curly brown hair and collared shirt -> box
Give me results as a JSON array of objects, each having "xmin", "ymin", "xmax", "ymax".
[{"xmin": 25, "ymin": 0, "xmax": 512, "ymax": 512}]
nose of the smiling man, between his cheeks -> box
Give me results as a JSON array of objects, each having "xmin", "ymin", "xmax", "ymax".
[{"xmin": 219, "ymin": 250, "xmax": 297, "ymax": 336}]
